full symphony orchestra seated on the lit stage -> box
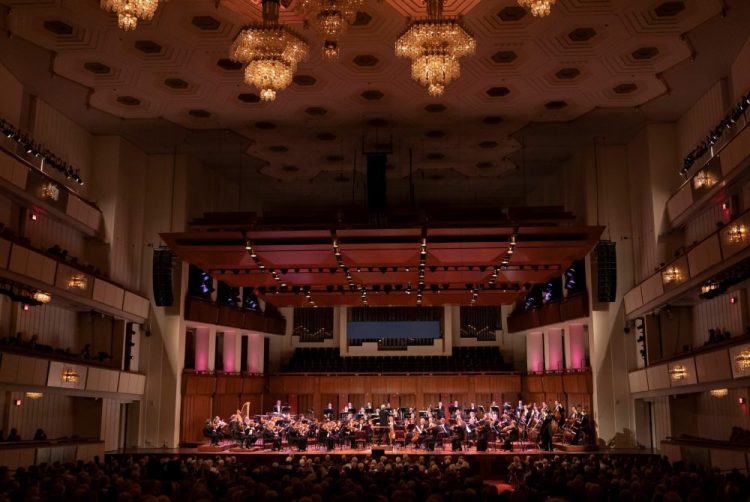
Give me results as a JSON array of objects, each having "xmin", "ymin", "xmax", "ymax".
[{"xmin": 203, "ymin": 400, "xmax": 595, "ymax": 452}]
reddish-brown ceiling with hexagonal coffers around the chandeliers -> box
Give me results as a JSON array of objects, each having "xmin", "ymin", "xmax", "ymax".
[{"xmin": 0, "ymin": 0, "xmax": 750, "ymax": 208}]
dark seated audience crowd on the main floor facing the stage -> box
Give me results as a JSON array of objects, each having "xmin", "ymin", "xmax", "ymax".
[{"xmin": 0, "ymin": 455, "xmax": 750, "ymax": 502}]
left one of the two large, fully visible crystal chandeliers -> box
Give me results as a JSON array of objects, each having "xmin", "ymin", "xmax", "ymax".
[{"xmin": 230, "ymin": 0, "xmax": 308, "ymax": 101}]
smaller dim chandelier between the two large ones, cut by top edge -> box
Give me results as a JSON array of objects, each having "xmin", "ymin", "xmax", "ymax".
[{"xmin": 297, "ymin": 0, "xmax": 363, "ymax": 59}]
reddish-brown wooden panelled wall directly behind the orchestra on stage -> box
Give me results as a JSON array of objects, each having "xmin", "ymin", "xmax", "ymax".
[{"xmin": 183, "ymin": 373, "xmax": 591, "ymax": 430}]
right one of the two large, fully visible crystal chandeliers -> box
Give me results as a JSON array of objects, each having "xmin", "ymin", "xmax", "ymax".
[{"xmin": 396, "ymin": 0, "xmax": 476, "ymax": 96}]
